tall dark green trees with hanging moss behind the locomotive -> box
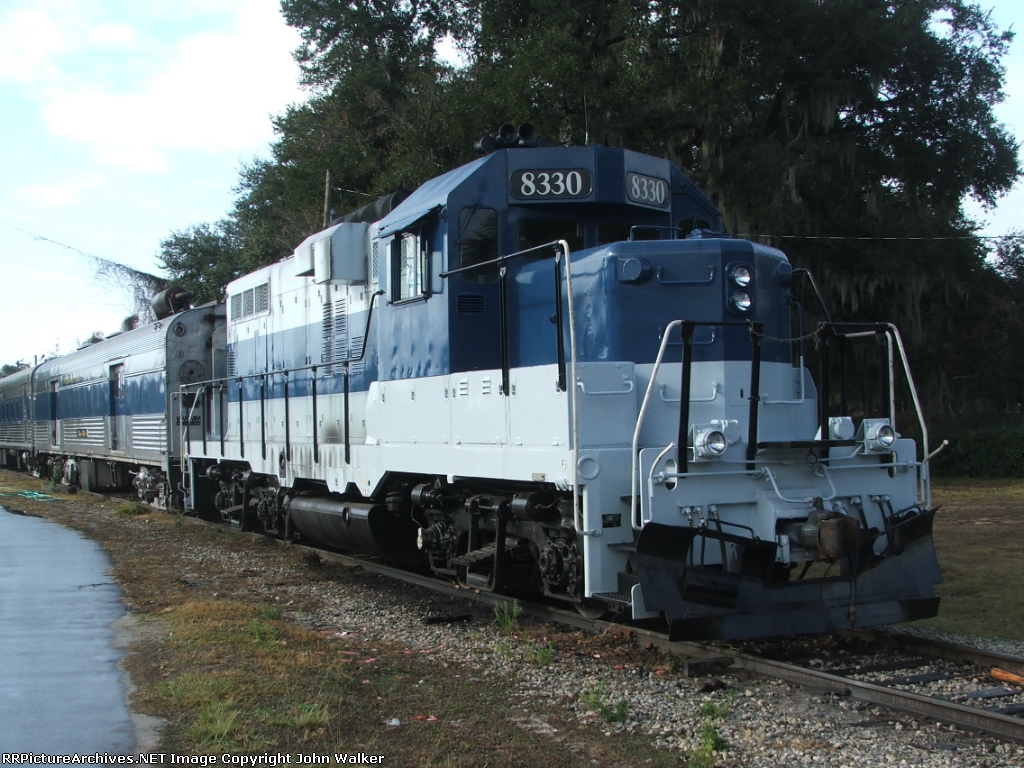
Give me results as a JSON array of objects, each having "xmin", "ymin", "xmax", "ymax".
[{"xmin": 164, "ymin": 0, "xmax": 1021, "ymax": 417}]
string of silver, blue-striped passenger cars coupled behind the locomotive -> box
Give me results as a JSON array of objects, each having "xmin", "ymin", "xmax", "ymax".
[{"xmin": 0, "ymin": 296, "xmax": 224, "ymax": 507}]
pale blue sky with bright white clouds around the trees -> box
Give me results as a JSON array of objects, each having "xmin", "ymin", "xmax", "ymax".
[{"xmin": 0, "ymin": 0, "xmax": 1024, "ymax": 364}]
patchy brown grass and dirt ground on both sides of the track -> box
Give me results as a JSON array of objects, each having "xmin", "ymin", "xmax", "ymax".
[{"xmin": 0, "ymin": 471, "xmax": 1024, "ymax": 768}]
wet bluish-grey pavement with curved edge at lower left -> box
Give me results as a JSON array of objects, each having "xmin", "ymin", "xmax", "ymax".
[{"xmin": 0, "ymin": 507, "xmax": 135, "ymax": 755}]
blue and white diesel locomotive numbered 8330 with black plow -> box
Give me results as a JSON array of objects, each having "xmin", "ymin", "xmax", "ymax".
[{"xmin": 178, "ymin": 127, "xmax": 941, "ymax": 638}]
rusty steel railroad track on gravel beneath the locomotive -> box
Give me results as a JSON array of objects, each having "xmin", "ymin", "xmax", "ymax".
[{"xmin": 262, "ymin": 535, "xmax": 1024, "ymax": 743}]
